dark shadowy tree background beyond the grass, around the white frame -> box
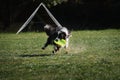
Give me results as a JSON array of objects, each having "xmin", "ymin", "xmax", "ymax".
[{"xmin": 0, "ymin": 0, "xmax": 120, "ymax": 32}]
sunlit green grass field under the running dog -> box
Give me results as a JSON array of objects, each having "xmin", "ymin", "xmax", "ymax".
[{"xmin": 0, "ymin": 30, "xmax": 120, "ymax": 80}]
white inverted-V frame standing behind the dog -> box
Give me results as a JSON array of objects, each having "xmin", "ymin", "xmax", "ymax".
[{"xmin": 16, "ymin": 3, "xmax": 62, "ymax": 34}]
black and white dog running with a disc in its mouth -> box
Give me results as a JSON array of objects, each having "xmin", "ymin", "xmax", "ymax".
[{"xmin": 42, "ymin": 24, "xmax": 71, "ymax": 53}]
